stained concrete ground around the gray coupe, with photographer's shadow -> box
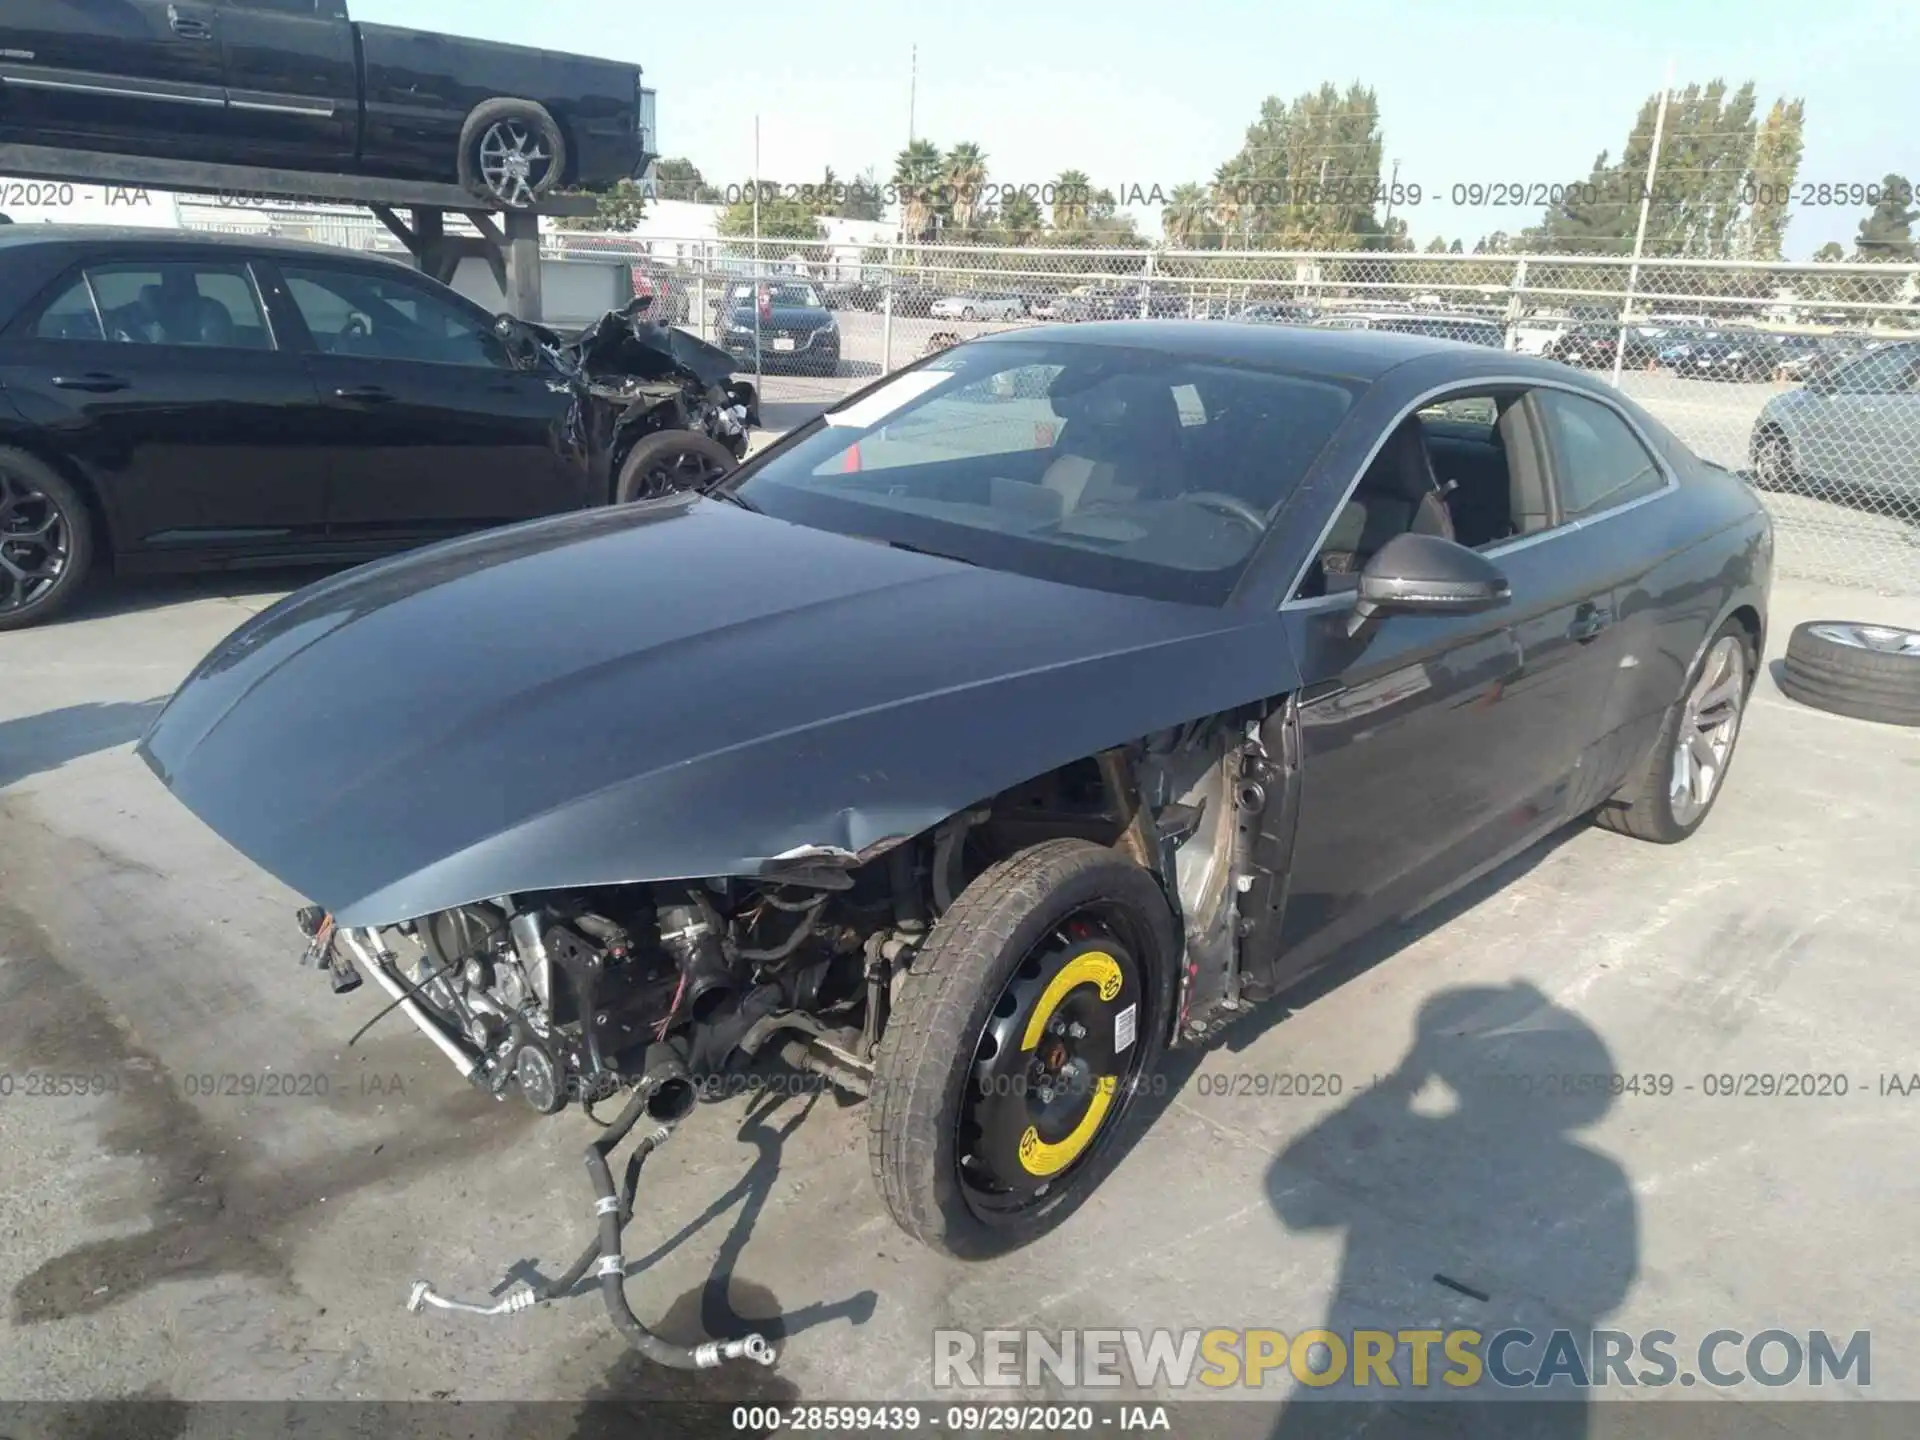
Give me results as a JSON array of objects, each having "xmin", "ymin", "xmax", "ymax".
[{"xmin": 0, "ymin": 552, "xmax": 1920, "ymax": 1402}]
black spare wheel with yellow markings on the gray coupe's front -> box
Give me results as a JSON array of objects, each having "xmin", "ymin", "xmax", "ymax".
[{"xmin": 868, "ymin": 839, "xmax": 1179, "ymax": 1260}]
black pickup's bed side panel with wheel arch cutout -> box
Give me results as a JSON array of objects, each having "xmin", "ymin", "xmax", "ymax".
[{"xmin": 357, "ymin": 25, "xmax": 641, "ymax": 184}]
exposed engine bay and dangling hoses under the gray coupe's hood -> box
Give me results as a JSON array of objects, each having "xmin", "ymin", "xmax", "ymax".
[{"xmin": 301, "ymin": 712, "xmax": 1292, "ymax": 1367}]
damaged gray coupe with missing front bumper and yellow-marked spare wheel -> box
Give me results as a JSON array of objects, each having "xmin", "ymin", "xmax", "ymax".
[{"xmin": 142, "ymin": 321, "xmax": 1772, "ymax": 1365}]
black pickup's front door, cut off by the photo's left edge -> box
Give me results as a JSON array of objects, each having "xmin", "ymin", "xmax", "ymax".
[{"xmin": 0, "ymin": 0, "xmax": 234, "ymax": 159}]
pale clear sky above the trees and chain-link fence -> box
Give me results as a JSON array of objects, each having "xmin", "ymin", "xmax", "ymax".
[{"xmin": 351, "ymin": 0, "xmax": 1920, "ymax": 259}]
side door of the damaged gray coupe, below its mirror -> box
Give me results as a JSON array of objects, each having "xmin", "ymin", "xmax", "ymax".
[{"xmin": 1269, "ymin": 396, "xmax": 1611, "ymax": 977}]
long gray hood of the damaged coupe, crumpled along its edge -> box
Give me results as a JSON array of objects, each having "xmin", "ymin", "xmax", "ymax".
[{"xmin": 140, "ymin": 495, "xmax": 1294, "ymax": 925}]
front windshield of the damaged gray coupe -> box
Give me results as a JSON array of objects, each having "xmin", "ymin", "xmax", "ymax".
[{"xmin": 735, "ymin": 340, "xmax": 1357, "ymax": 605}]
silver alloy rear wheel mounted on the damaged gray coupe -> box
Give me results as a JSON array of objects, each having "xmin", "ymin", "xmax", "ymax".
[{"xmin": 1594, "ymin": 620, "xmax": 1753, "ymax": 845}]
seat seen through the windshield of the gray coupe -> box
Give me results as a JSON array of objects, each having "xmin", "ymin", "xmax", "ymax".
[{"xmin": 1041, "ymin": 374, "xmax": 1183, "ymax": 515}]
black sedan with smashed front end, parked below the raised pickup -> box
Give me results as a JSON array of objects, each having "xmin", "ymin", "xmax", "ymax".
[{"xmin": 0, "ymin": 225, "xmax": 756, "ymax": 630}]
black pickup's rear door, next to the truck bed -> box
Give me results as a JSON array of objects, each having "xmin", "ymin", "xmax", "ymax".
[{"xmin": 217, "ymin": 0, "xmax": 359, "ymax": 169}]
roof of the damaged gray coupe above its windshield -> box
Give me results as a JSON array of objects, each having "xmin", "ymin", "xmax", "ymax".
[{"xmin": 966, "ymin": 321, "xmax": 1567, "ymax": 380}]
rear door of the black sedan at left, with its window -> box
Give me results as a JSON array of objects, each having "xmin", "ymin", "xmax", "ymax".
[{"xmin": 0, "ymin": 252, "xmax": 326, "ymax": 557}]
